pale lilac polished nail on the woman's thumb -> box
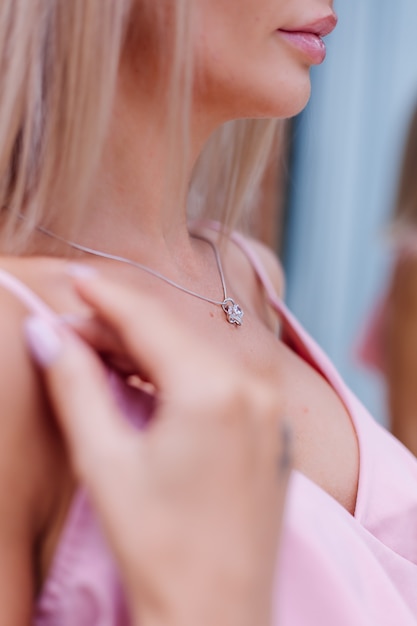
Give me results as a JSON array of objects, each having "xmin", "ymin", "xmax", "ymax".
[{"xmin": 24, "ymin": 316, "xmax": 62, "ymax": 367}]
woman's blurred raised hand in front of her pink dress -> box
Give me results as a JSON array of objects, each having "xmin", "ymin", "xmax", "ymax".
[{"xmin": 22, "ymin": 277, "xmax": 288, "ymax": 626}]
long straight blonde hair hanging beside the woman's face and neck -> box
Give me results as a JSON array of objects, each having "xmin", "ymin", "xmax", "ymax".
[{"xmin": 0, "ymin": 0, "xmax": 277, "ymax": 253}]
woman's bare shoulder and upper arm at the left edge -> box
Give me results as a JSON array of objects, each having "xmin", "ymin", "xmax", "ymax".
[{"xmin": 0, "ymin": 259, "xmax": 72, "ymax": 625}]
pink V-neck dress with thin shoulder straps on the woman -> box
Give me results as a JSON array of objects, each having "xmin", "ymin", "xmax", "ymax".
[{"xmin": 0, "ymin": 234, "xmax": 417, "ymax": 626}]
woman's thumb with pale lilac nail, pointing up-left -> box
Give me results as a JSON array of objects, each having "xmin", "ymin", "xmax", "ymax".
[{"xmin": 24, "ymin": 317, "xmax": 137, "ymax": 487}]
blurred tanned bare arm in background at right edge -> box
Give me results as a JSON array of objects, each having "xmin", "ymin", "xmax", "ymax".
[{"xmin": 385, "ymin": 257, "xmax": 417, "ymax": 454}]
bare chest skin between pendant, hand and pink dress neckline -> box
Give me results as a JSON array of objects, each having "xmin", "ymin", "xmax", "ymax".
[{"xmin": 193, "ymin": 316, "xmax": 359, "ymax": 513}]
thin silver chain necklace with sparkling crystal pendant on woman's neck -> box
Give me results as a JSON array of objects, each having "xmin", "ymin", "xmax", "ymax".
[{"xmin": 37, "ymin": 226, "xmax": 244, "ymax": 326}]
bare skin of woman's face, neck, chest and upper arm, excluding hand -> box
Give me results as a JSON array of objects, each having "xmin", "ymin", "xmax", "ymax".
[{"xmin": 0, "ymin": 0, "xmax": 359, "ymax": 626}]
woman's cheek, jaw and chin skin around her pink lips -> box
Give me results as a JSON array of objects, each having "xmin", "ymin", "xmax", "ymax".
[{"xmin": 191, "ymin": 0, "xmax": 318, "ymax": 125}]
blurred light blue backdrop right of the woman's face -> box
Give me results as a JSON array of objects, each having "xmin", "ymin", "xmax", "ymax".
[{"xmin": 284, "ymin": 0, "xmax": 417, "ymax": 422}]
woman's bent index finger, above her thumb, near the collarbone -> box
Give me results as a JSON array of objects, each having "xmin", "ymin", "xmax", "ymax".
[{"xmin": 75, "ymin": 276, "xmax": 214, "ymax": 391}]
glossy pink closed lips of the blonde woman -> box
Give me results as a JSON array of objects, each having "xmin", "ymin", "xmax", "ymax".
[{"xmin": 278, "ymin": 13, "xmax": 337, "ymax": 65}]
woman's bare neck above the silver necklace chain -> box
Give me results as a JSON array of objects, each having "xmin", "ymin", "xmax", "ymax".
[{"xmin": 46, "ymin": 66, "xmax": 218, "ymax": 263}]
